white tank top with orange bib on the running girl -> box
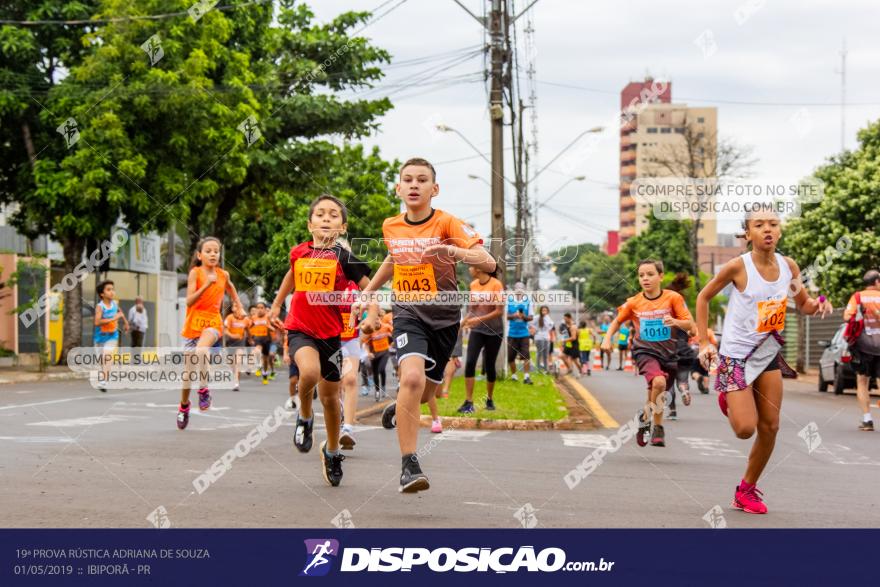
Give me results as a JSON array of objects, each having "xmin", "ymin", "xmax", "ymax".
[{"xmin": 718, "ymin": 252, "xmax": 791, "ymax": 359}]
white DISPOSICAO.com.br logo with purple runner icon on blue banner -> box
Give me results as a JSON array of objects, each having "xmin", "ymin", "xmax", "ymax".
[{"xmin": 300, "ymin": 538, "xmax": 614, "ymax": 577}]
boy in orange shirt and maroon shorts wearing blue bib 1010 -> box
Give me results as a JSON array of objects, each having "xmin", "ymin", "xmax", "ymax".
[{"xmin": 602, "ymin": 259, "xmax": 694, "ymax": 446}]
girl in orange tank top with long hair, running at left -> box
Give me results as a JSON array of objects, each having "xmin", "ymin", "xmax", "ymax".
[{"xmin": 177, "ymin": 236, "xmax": 245, "ymax": 430}]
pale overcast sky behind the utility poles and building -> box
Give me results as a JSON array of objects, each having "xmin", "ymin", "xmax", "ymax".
[{"xmin": 309, "ymin": 0, "xmax": 880, "ymax": 250}]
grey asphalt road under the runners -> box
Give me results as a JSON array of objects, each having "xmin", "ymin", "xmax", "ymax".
[{"xmin": 0, "ymin": 371, "xmax": 880, "ymax": 528}]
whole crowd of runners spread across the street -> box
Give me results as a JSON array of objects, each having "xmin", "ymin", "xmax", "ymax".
[{"xmin": 95, "ymin": 159, "xmax": 880, "ymax": 513}]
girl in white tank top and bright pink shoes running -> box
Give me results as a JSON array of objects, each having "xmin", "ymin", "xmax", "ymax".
[{"xmin": 697, "ymin": 213, "xmax": 831, "ymax": 514}]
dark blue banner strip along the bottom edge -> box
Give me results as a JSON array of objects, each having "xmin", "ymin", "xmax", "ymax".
[{"xmin": 0, "ymin": 529, "xmax": 880, "ymax": 587}]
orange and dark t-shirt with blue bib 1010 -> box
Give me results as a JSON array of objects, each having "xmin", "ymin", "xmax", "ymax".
[{"xmin": 617, "ymin": 289, "xmax": 693, "ymax": 361}]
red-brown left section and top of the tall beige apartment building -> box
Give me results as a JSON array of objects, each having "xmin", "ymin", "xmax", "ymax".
[{"xmin": 620, "ymin": 78, "xmax": 672, "ymax": 244}]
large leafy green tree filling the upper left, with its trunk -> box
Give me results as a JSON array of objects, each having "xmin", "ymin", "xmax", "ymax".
[{"xmin": 0, "ymin": 0, "xmax": 390, "ymax": 360}]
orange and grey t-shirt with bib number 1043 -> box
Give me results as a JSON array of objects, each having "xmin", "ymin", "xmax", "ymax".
[{"xmin": 382, "ymin": 209, "xmax": 483, "ymax": 328}]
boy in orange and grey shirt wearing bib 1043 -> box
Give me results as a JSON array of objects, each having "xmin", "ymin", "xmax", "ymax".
[{"xmin": 356, "ymin": 159, "xmax": 496, "ymax": 493}]
